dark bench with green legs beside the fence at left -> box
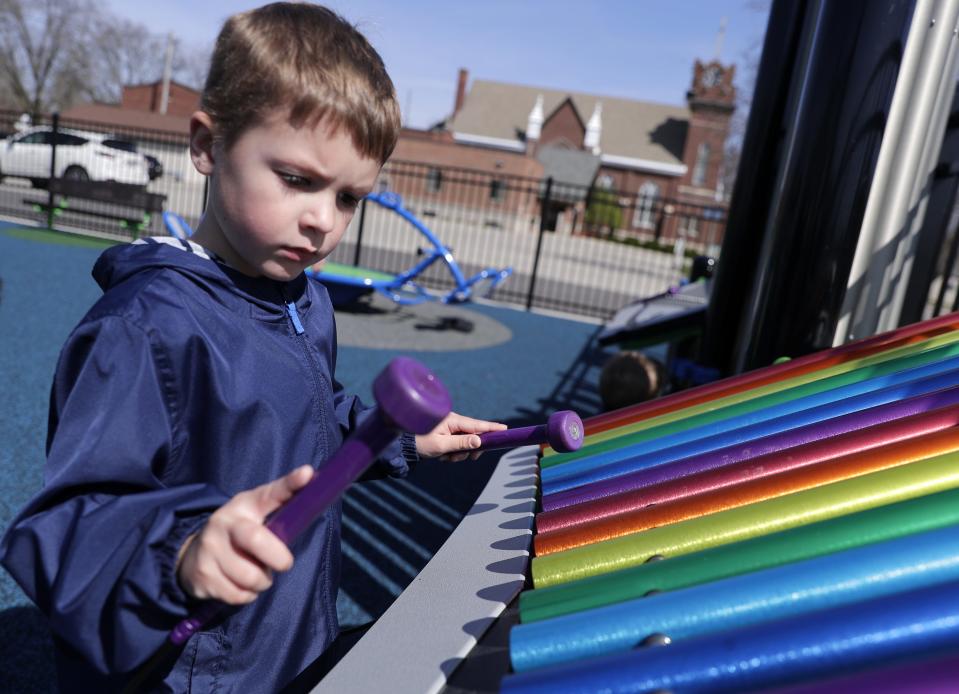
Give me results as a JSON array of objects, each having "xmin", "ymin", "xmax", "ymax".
[{"xmin": 23, "ymin": 178, "xmax": 166, "ymax": 232}]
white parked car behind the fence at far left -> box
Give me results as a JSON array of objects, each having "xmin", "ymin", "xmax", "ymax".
[{"xmin": 0, "ymin": 127, "xmax": 150, "ymax": 187}]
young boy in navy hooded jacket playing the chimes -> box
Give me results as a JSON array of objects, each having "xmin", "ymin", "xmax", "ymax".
[{"xmin": 0, "ymin": 3, "xmax": 503, "ymax": 692}]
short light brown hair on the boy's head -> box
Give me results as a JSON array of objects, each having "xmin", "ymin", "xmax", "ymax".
[{"xmin": 200, "ymin": 2, "xmax": 400, "ymax": 163}]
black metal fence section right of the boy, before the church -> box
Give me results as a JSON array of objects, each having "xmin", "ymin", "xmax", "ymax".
[{"xmin": 331, "ymin": 161, "xmax": 725, "ymax": 319}]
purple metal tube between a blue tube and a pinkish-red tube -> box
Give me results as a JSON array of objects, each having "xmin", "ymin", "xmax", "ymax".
[{"xmin": 542, "ymin": 386, "xmax": 959, "ymax": 511}]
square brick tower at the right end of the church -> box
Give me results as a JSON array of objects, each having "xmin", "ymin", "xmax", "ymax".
[{"xmin": 679, "ymin": 60, "xmax": 736, "ymax": 198}]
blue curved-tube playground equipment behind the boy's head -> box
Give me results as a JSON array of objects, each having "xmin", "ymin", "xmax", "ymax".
[{"xmin": 163, "ymin": 192, "xmax": 513, "ymax": 306}]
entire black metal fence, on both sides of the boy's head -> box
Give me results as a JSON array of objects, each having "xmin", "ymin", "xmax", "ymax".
[{"xmin": 0, "ymin": 111, "xmax": 725, "ymax": 319}]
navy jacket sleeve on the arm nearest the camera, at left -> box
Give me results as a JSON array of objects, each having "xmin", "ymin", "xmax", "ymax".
[{"xmin": 0, "ymin": 316, "xmax": 227, "ymax": 674}]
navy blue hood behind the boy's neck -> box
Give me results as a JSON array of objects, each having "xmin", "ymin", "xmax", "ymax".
[{"xmin": 93, "ymin": 242, "xmax": 316, "ymax": 316}]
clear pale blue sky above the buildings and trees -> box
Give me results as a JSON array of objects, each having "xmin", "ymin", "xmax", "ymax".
[{"xmin": 107, "ymin": 0, "xmax": 768, "ymax": 128}]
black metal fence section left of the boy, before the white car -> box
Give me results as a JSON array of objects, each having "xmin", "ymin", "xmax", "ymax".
[{"xmin": 0, "ymin": 111, "xmax": 206, "ymax": 239}]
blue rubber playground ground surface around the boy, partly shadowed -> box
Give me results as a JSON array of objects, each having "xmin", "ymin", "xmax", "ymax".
[{"xmin": 0, "ymin": 222, "xmax": 610, "ymax": 692}]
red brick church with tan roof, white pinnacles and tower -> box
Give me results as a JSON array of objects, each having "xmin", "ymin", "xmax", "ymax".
[{"xmin": 393, "ymin": 61, "xmax": 735, "ymax": 242}]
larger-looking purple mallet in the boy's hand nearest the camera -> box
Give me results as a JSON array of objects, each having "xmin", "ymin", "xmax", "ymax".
[{"xmin": 169, "ymin": 357, "xmax": 450, "ymax": 646}]
